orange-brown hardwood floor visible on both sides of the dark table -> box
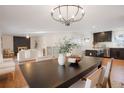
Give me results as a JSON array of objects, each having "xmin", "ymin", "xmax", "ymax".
[{"xmin": 0, "ymin": 58, "xmax": 124, "ymax": 88}]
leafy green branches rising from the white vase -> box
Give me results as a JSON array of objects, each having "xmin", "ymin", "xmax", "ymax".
[{"xmin": 59, "ymin": 38, "xmax": 78, "ymax": 54}]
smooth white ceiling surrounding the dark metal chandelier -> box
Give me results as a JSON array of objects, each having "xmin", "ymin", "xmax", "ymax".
[{"xmin": 0, "ymin": 5, "xmax": 124, "ymax": 35}]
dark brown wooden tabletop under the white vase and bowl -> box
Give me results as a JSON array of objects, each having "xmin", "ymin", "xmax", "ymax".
[{"xmin": 20, "ymin": 57, "xmax": 101, "ymax": 88}]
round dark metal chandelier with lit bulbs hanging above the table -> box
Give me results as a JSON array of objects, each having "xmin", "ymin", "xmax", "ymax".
[{"xmin": 51, "ymin": 5, "xmax": 84, "ymax": 26}]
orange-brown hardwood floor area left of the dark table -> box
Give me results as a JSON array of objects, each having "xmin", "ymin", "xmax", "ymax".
[{"xmin": 0, "ymin": 65, "xmax": 28, "ymax": 88}]
